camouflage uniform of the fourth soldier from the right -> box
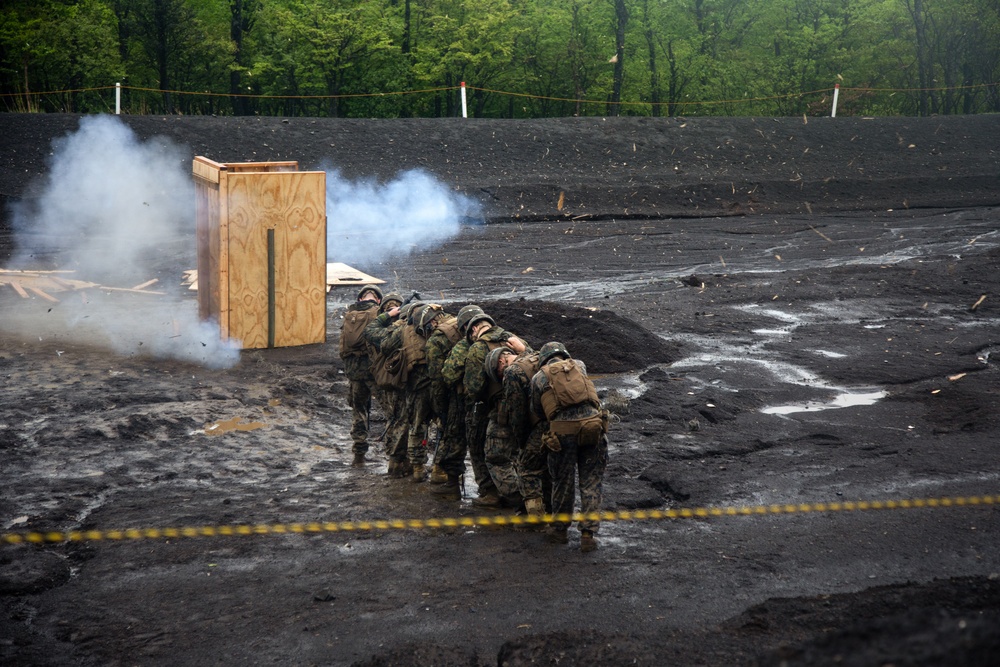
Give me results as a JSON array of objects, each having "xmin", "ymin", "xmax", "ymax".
[{"xmin": 425, "ymin": 313, "xmax": 465, "ymax": 476}]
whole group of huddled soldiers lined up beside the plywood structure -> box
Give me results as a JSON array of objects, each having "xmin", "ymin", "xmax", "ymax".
[{"xmin": 340, "ymin": 285, "xmax": 608, "ymax": 551}]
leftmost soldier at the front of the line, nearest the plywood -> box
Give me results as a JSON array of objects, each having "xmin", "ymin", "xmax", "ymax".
[{"xmin": 340, "ymin": 285, "xmax": 382, "ymax": 467}]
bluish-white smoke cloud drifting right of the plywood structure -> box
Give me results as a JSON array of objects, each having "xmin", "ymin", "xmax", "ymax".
[{"xmin": 326, "ymin": 169, "xmax": 482, "ymax": 268}]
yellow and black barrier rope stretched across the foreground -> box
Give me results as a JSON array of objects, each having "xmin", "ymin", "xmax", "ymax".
[{"xmin": 0, "ymin": 496, "xmax": 1000, "ymax": 544}]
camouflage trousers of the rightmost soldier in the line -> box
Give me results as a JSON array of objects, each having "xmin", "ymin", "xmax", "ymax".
[{"xmin": 549, "ymin": 435, "xmax": 608, "ymax": 533}]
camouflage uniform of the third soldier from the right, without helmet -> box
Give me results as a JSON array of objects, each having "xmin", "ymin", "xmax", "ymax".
[{"xmin": 464, "ymin": 325, "xmax": 521, "ymax": 503}]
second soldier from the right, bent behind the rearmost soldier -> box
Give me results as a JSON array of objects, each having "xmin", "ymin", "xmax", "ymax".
[{"xmin": 486, "ymin": 347, "xmax": 552, "ymax": 519}]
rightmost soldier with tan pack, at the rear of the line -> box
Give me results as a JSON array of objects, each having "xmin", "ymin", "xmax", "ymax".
[{"xmin": 531, "ymin": 342, "xmax": 608, "ymax": 551}]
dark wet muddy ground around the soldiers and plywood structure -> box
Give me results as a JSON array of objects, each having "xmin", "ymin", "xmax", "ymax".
[{"xmin": 0, "ymin": 115, "xmax": 1000, "ymax": 665}]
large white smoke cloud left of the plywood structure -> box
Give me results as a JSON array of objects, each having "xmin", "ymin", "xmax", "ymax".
[{"xmin": 6, "ymin": 116, "xmax": 240, "ymax": 368}]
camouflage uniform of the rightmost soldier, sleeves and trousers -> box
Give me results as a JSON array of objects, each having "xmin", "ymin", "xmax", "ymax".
[{"xmin": 531, "ymin": 359, "xmax": 608, "ymax": 533}]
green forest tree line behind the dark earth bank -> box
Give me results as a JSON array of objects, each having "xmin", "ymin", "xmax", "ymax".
[{"xmin": 0, "ymin": 0, "xmax": 1000, "ymax": 118}]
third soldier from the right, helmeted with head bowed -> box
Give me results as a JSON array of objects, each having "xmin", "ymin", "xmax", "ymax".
[{"xmin": 463, "ymin": 311, "xmax": 529, "ymax": 507}]
